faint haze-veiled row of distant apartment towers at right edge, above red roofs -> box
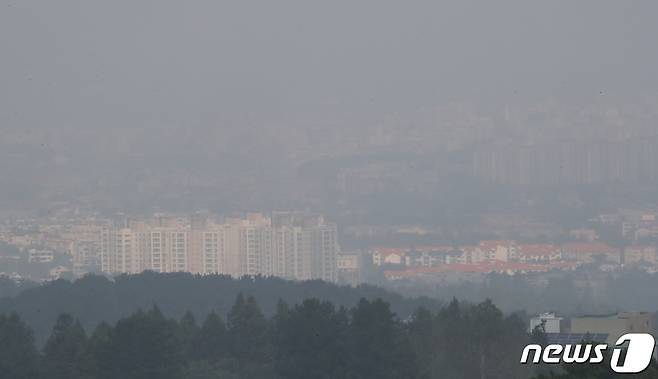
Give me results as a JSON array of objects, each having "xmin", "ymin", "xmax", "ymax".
[{"xmin": 473, "ymin": 136, "xmax": 658, "ymax": 187}]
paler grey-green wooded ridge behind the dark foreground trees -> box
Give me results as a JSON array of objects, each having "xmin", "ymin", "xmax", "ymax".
[{"xmin": 0, "ymin": 272, "xmax": 441, "ymax": 344}]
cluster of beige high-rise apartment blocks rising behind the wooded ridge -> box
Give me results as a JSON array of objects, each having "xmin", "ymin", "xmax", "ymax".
[{"xmin": 100, "ymin": 212, "xmax": 339, "ymax": 281}]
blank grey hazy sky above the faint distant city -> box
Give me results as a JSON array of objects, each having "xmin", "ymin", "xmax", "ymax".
[{"xmin": 0, "ymin": 0, "xmax": 658, "ymax": 128}]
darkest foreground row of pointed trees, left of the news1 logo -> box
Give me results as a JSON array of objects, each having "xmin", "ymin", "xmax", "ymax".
[{"xmin": 0, "ymin": 294, "xmax": 530, "ymax": 379}]
